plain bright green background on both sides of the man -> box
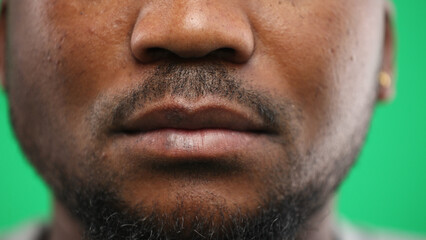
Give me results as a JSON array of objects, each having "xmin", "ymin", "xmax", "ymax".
[{"xmin": 0, "ymin": 0, "xmax": 426, "ymax": 235}]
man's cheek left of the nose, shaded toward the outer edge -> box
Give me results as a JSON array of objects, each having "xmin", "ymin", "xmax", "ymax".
[{"xmin": 7, "ymin": 0, "xmax": 145, "ymax": 180}]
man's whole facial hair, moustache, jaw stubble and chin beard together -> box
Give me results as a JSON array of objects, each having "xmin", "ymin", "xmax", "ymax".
[{"xmin": 8, "ymin": 64, "xmax": 372, "ymax": 240}]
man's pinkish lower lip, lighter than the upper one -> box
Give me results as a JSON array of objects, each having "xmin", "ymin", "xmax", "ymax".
[{"xmin": 116, "ymin": 129, "xmax": 262, "ymax": 159}]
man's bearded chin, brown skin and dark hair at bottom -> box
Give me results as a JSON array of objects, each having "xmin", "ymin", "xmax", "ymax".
[{"xmin": 69, "ymin": 184, "xmax": 312, "ymax": 240}]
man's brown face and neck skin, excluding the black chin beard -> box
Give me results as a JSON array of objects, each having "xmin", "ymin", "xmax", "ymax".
[{"xmin": 1, "ymin": 0, "xmax": 393, "ymax": 240}]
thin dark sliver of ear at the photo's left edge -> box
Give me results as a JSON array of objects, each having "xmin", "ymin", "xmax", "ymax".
[{"xmin": 0, "ymin": 0, "xmax": 7, "ymax": 91}]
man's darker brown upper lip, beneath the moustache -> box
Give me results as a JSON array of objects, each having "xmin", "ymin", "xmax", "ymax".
[{"xmin": 120, "ymin": 99, "xmax": 274, "ymax": 133}]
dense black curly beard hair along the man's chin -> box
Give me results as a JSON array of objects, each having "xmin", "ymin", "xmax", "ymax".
[{"xmin": 62, "ymin": 182, "xmax": 322, "ymax": 240}]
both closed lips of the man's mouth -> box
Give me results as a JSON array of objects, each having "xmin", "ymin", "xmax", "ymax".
[{"xmin": 111, "ymin": 96, "xmax": 273, "ymax": 160}]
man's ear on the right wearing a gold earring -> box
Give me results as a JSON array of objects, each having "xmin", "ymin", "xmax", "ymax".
[{"xmin": 377, "ymin": 1, "xmax": 396, "ymax": 102}]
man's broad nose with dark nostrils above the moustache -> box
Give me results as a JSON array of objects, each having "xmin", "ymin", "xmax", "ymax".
[{"xmin": 130, "ymin": 0, "xmax": 254, "ymax": 63}]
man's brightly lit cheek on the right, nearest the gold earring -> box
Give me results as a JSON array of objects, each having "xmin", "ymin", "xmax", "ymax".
[{"xmin": 248, "ymin": 0, "xmax": 382, "ymax": 146}]
